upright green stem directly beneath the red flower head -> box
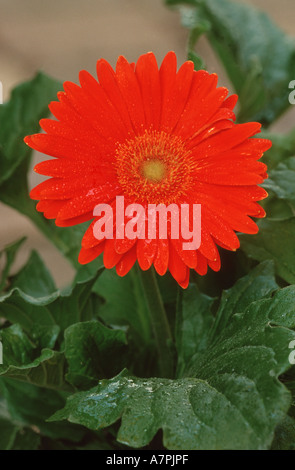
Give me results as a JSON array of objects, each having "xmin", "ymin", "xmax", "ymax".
[{"xmin": 138, "ymin": 268, "xmax": 174, "ymax": 378}]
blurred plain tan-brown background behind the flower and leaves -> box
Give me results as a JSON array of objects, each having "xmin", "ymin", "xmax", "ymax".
[{"xmin": 0, "ymin": 0, "xmax": 295, "ymax": 286}]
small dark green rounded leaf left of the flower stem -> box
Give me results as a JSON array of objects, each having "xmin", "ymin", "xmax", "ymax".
[{"xmin": 65, "ymin": 321, "xmax": 127, "ymax": 389}]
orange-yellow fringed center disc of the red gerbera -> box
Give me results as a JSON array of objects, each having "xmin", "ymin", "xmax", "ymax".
[{"xmin": 115, "ymin": 130, "xmax": 196, "ymax": 205}]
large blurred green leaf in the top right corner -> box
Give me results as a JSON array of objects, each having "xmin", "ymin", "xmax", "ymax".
[{"xmin": 166, "ymin": 0, "xmax": 295, "ymax": 125}]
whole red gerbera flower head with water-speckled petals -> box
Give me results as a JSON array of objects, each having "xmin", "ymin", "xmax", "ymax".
[{"xmin": 25, "ymin": 52, "xmax": 271, "ymax": 287}]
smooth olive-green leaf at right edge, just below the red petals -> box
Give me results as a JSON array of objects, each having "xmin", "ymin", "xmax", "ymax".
[{"xmin": 240, "ymin": 217, "xmax": 295, "ymax": 284}]
